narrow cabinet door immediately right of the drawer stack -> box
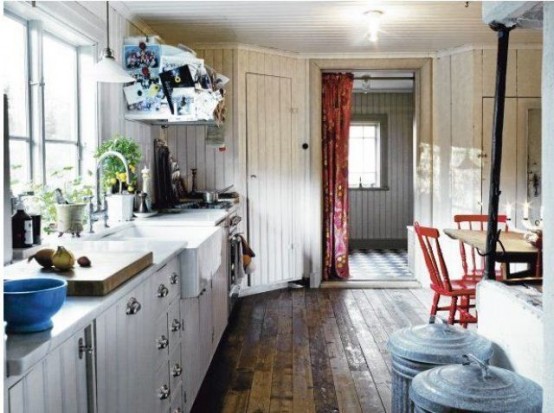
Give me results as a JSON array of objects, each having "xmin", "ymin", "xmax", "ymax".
[{"xmin": 180, "ymin": 297, "xmax": 199, "ymax": 412}]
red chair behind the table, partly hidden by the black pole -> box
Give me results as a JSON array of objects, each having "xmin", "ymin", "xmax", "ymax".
[{"xmin": 454, "ymin": 215, "xmax": 508, "ymax": 282}]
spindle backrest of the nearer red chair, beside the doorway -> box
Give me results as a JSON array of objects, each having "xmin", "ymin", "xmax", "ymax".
[{"xmin": 414, "ymin": 221, "xmax": 452, "ymax": 291}]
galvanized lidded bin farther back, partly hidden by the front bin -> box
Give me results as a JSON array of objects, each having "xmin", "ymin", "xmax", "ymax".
[{"xmin": 388, "ymin": 324, "xmax": 493, "ymax": 413}]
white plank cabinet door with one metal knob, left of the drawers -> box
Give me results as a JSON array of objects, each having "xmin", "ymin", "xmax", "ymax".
[{"xmin": 96, "ymin": 283, "xmax": 154, "ymax": 413}]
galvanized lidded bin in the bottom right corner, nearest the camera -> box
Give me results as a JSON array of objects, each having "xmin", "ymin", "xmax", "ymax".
[{"xmin": 410, "ymin": 352, "xmax": 542, "ymax": 413}]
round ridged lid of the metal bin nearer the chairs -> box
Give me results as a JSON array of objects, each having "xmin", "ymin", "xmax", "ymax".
[{"xmin": 388, "ymin": 324, "xmax": 493, "ymax": 365}]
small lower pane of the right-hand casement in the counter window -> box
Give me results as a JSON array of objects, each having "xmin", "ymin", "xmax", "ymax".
[{"xmin": 46, "ymin": 142, "xmax": 78, "ymax": 188}]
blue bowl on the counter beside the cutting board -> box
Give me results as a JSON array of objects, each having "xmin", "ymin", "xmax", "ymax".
[{"xmin": 4, "ymin": 277, "xmax": 67, "ymax": 333}]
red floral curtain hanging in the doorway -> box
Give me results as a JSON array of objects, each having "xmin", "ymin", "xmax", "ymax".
[{"xmin": 322, "ymin": 73, "xmax": 354, "ymax": 280}]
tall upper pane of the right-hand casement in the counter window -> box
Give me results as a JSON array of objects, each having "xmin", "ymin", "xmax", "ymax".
[{"xmin": 43, "ymin": 35, "xmax": 77, "ymax": 141}]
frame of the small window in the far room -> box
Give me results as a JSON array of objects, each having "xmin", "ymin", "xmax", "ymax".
[{"xmin": 348, "ymin": 113, "xmax": 390, "ymax": 191}]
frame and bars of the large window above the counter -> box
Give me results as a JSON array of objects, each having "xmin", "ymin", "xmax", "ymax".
[{"xmin": 4, "ymin": 10, "xmax": 99, "ymax": 189}]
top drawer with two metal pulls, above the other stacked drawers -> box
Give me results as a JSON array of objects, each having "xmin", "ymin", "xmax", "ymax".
[{"xmin": 149, "ymin": 260, "xmax": 180, "ymax": 316}]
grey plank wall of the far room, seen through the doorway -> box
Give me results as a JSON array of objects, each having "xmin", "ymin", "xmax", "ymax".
[{"xmin": 349, "ymin": 93, "xmax": 414, "ymax": 247}]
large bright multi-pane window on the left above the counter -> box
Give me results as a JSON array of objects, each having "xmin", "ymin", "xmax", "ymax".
[{"xmin": 3, "ymin": 15, "xmax": 96, "ymax": 194}]
